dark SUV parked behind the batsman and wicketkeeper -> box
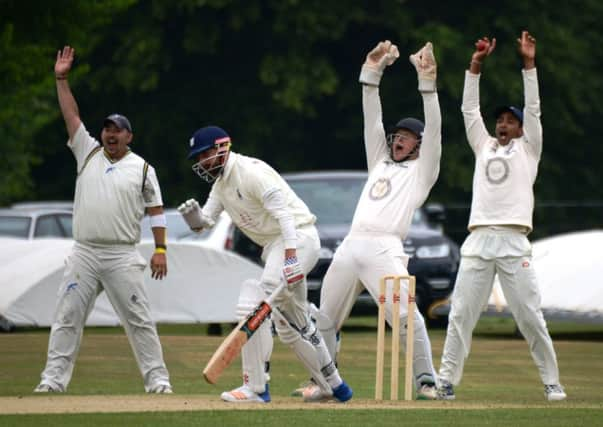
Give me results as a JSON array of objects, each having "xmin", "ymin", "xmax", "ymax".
[{"xmin": 233, "ymin": 171, "xmax": 460, "ymax": 323}]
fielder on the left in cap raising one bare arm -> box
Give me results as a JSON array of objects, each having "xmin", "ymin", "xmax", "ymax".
[{"xmin": 34, "ymin": 46, "xmax": 172, "ymax": 393}]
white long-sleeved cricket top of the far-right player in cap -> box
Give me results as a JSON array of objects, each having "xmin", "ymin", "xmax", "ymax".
[{"xmin": 462, "ymin": 68, "xmax": 542, "ymax": 231}]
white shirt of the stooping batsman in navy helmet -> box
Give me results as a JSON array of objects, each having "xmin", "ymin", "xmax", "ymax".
[{"xmin": 202, "ymin": 151, "xmax": 316, "ymax": 247}]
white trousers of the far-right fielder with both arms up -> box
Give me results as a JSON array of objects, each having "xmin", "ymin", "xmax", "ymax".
[{"xmin": 440, "ymin": 227, "xmax": 559, "ymax": 385}]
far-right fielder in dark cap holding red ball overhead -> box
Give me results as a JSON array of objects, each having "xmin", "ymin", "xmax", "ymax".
[{"xmin": 438, "ymin": 31, "xmax": 566, "ymax": 400}]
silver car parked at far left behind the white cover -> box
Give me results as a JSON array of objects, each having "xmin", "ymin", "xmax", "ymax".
[{"xmin": 0, "ymin": 206, "xmax": 73, "ymax": 239}]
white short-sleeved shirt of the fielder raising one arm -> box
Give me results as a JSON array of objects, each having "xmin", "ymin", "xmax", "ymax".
[{"xmin": 67, "ymin": 123, "xmax": 163, "ymax": 244}]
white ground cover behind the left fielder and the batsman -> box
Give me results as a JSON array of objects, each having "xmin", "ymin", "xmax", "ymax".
[{"xmin": 0, "ymin": 238, "xmax": 262, "ymax": 326}]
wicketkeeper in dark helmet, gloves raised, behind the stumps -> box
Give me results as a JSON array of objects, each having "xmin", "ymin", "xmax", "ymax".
[{"xmin": 304, "ymin": 40, "xmax": 441, "ymax": 399}]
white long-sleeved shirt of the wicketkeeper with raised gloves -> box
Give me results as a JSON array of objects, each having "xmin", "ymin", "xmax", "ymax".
[{"xmin": 351, "ymin": 85, "xmax": 442, "ymax": 238}]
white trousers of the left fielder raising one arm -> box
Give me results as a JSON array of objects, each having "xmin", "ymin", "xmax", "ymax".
[{"xmin": 41, "ymin": 242, "xmax": 170, "ymax": 392}]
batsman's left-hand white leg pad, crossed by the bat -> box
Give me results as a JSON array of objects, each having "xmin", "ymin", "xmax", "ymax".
[{"xmin": 237, "ymin": 280, "xmax": 274, "ymax": 393}]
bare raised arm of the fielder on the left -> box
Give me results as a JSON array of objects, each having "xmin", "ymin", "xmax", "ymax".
[{"xmin": 54, "ymin": 46, "xmax": 82, "ymax": 139}]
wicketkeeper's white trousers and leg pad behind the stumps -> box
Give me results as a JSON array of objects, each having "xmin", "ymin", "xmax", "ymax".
[{"xmin": 319, "ymin": 232, "xmax": 436, "ymax": 387}]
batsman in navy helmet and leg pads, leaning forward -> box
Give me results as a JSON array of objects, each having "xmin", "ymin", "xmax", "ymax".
[{"xmin": 178, "ymin": 126, "xmax": 352, "ymax": 403}]
